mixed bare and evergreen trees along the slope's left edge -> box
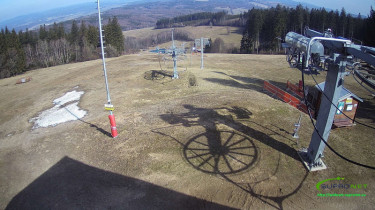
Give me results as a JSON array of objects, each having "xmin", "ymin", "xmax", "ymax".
[{"xmin": 0, "ymin": 17, "xmax": 124, "ymax": 79}]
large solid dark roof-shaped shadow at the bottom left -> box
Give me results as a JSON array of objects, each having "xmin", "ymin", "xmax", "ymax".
[{"xmin": 6, "ymin": 157, "xmax": 232, "ymax": 210}]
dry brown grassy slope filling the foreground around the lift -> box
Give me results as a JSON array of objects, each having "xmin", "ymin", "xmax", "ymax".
[{"xmin": 0, "ymin": 53, "xmax": 375, "ymax": 209}]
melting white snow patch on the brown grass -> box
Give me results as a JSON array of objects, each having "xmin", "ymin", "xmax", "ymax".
[{"xmin": 30, "ymin": 90, "xmax": 87, "ymax": 129}]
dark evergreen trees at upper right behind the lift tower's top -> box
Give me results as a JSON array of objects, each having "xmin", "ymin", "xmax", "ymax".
[{"xmin": 240, "ymin": 5, "xmax": 375, "ymax": 53}]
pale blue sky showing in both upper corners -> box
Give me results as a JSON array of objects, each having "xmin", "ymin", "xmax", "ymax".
[{"xmin": 0, "ymin": 0, "xmax": 375, "ymax": 21}]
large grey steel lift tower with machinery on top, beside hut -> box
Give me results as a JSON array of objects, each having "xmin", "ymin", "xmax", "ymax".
[{"xmin": 285, "ymin": 28, "xmax": 375, "ymax": 171}]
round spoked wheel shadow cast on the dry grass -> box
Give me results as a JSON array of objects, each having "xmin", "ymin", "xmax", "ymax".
[{"xmin": 183, "ymin": 130, "xmax": 258, "ymax": 175}]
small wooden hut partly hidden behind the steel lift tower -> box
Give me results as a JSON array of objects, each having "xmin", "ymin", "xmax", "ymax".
[{"xmin": 307, "ymin": 82, "xmax": 363, "ymax": 127}]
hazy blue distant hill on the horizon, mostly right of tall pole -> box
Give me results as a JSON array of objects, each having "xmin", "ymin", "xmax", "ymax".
[{"xmin": 82, "ymin": 0, "xmax": 324, "ymax": 31}]
